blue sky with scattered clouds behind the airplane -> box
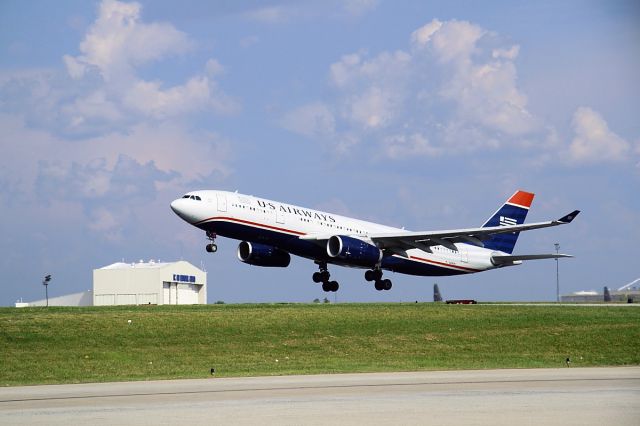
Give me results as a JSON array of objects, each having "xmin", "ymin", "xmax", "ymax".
[{"xmin": 0, "ymin": 0, "xmax": 640, "ymax": 306}]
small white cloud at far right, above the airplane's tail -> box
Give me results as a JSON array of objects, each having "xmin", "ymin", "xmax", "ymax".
[{"xmin": 569, "ymin": 107, "xmax": 631, "ymax": 163}]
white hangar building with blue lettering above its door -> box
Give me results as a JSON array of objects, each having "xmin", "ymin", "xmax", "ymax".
[{"xmin": 93, "ymin": 260, "xmax": 207, "ymax": 306}]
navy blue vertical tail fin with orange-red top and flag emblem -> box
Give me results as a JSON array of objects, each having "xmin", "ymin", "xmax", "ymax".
[{"xmin": 482, "ymin": 191, "xmax": 534, "ymax": 254}]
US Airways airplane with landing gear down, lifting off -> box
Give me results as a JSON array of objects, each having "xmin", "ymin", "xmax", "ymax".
[{"xmin": 171, "ymin": 190, "xmax": 580, "ymax": 292}]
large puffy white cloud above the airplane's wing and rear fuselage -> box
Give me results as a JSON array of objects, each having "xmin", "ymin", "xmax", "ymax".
[{"xmin": 288, "ymin": 19, "xmax": 540, "ymax": 158}]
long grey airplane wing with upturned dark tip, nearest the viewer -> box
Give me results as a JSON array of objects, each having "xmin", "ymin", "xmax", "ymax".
[{"xmin": 367, "ymin": 210, "xmax": 580, "ymax": 254}]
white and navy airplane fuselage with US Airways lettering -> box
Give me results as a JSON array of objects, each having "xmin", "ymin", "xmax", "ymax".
[{"xmin": 171, "ymin": 190, "xmax": 496, "ymax": 275}]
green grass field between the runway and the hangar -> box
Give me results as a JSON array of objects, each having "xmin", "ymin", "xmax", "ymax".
[{"xmin": 0, "ymin": 303, "xmax": 640, "ymax": 386}]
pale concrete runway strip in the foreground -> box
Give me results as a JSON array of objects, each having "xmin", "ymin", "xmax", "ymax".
[{"xmin": 0, "ymin": 367, "xmax": 640, "ymax": 426}]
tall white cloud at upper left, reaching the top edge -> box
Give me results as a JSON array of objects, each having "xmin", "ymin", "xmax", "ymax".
[{"xmin": 49, "ymin": 0, "xmax": 239, "ymax": 134}]
